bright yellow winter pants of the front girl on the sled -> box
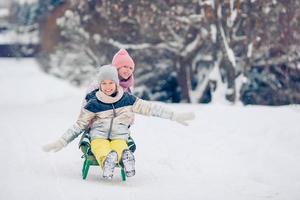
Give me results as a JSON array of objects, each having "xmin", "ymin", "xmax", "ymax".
[{"xmin": 91, "ymin": 138, "xmax": 128, "ymax": 167}]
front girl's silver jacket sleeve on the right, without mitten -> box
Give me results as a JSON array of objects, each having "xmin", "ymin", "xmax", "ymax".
[{"xmin": 132, "ymin": 98, "xmax": 174, "ymax": 119}]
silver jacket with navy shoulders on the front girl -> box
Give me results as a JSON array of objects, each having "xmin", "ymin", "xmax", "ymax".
[{"xmin": 62, "ymin": 87, "xmax": 173, "ymax": 143}]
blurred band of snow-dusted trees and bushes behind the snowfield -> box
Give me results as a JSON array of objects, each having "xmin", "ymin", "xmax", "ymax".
[{"xmin": 0, "ymin": 0, "xmax": 300, "ymax": 105}]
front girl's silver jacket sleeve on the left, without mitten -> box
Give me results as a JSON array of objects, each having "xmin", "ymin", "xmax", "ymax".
[{"xmin": 62, "ymin": 108, "xmax": 96, "ymax": 143}]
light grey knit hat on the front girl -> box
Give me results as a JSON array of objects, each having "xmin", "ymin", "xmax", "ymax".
[{"xmin": 97, "ymin": 65, "xmax": 119, "ymax": 85}]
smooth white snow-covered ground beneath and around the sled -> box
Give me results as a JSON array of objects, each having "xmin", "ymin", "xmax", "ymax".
[{"xmin": 0, "ymin": 59, "xmax": 300, "ymax": 200}]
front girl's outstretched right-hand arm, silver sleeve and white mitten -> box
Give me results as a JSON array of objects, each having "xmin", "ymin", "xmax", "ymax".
[{"xmin": 132, "ymin": 98, "xmax": 195, "ymax": 126}]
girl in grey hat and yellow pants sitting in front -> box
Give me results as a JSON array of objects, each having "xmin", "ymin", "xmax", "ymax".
[{"xmin": 43, "ymin": 65, "xmax": 195, "ymax": 179}]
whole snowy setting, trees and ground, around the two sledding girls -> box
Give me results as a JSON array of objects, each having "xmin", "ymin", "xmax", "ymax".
[{"xmin": 0, "ymin": 0, "xmax": 300, "ymax": 200}]
